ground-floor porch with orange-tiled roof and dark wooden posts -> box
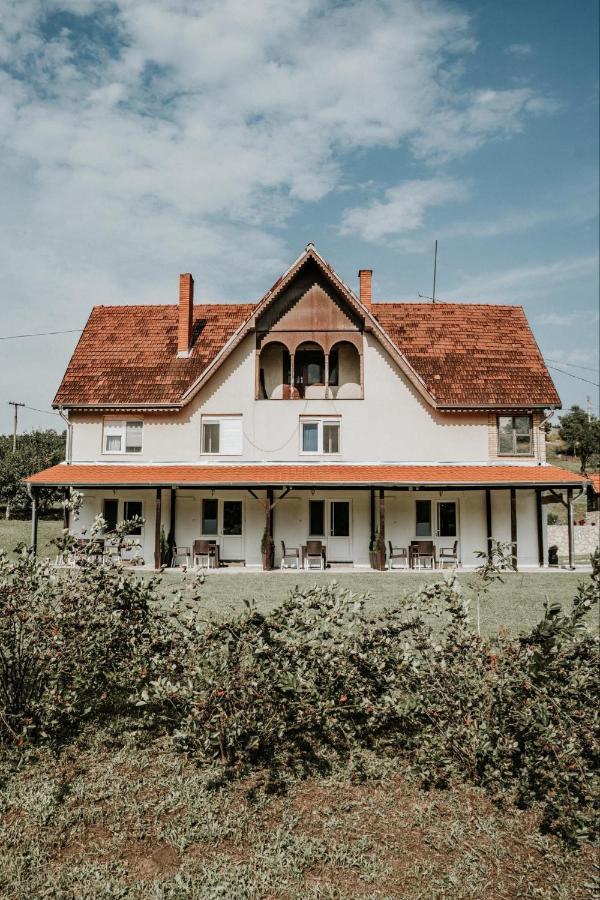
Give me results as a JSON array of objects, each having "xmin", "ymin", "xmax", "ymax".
[{"xmin": 24, "ymin": 464, "xmax": 583, "ymax": 570}]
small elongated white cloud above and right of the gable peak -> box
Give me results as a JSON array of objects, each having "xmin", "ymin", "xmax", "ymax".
[{"xmin": 340, "ymin": 178, "xmax": 467, "ymax": 241}]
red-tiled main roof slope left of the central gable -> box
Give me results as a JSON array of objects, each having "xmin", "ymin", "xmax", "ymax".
[{"xmin": 54, "ymin": 303, "xmax": 254, "ymax": 406}]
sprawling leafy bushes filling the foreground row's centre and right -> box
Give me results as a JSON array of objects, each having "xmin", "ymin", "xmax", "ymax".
[{"xmin": 138, "ymin": 557, "xmax": 598, "ymax": 840}]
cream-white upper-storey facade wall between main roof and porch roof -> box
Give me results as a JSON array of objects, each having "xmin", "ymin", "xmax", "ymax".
[{"xmin": 72, "ymin": 336, "xmax": 496, "ymax": 464}]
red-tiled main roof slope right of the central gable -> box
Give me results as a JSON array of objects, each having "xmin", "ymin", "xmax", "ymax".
[{"xmin": 373, "ymin": 303, "xmax": 560, "ymax": 407}]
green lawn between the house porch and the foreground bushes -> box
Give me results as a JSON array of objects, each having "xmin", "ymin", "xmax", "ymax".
[{"xmin": 0, "ymin": 519, "xmax": 584, "ymax": 634}]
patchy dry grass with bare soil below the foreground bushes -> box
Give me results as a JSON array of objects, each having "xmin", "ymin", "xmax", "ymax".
[{"xmin": 0, "ymin": 733, "xmax": 594, "ymax": 900}]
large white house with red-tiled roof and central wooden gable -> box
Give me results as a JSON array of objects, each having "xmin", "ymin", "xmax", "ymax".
[{"xmin": 29, "ymin": 245, "xmax": 581, "ymax": 567}]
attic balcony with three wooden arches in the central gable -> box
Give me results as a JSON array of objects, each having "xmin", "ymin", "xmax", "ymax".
[{"xmin": 256, "ymin": 335, "xmax": 364, "ymax": 400}]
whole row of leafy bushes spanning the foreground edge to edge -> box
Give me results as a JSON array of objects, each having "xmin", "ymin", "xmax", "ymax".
[{"xmin": 0, "ymin": 548, "xmax": 600, "ymax": 842}]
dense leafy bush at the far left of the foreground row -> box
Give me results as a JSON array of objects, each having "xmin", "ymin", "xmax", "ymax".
[{"xmin": 0, "ymin": 551, "xmax": 165, "ymax": 745}]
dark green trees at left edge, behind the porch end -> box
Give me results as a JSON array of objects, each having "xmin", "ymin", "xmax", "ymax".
[{"xmin": 0, "ymin": 428, "xmax": 66, "ymax": 519}]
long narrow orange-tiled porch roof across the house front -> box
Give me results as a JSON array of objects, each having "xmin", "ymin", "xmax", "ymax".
[{"xmin": 26, "ymin": 463, "xmax": 585, "ymax": 488}]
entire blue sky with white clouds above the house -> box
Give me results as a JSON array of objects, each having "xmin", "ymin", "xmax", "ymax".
[{"xmin": 0, "ymin": 0, "xmax": 600, "ymax": 433}]
